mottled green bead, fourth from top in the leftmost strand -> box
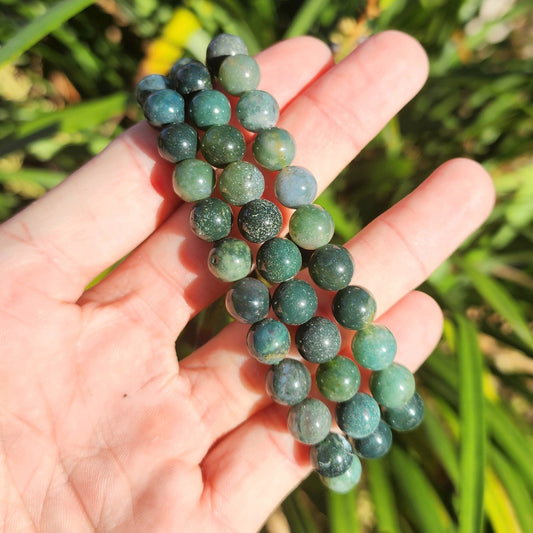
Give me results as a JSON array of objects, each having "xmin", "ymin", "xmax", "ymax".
[{"xmin": 172, "ymin": 159, "xmax": 216, "ymax": 202}]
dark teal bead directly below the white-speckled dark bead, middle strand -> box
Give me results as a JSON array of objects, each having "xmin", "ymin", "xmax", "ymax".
[{"xmin": 256, "ymin": 237, "xmax": 302, "ymax": 283}]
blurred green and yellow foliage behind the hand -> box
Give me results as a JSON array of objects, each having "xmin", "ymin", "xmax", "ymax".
[{"xmin": 0, "ymin": 0, "xmax": 533, "ymax": 533}]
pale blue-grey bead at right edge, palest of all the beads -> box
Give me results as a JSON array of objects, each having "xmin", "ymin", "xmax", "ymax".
[{"xmin": 274, "ymin": 166, "xmax": 317, "ymax": 209}]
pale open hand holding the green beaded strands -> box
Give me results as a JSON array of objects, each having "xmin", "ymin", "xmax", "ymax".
[{"xmin": 0, "ymin": 32, "xmax": 493, "ymax": 533}]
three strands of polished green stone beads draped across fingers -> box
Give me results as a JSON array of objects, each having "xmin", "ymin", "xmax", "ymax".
[{"xmin": 137, "ymin": 34, "xmax": 424, "ymax": 492}]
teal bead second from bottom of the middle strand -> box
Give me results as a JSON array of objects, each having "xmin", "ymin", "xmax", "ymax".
[{"xmin": 335, "ymin": 392, "xmax": 381, "ymax": 439}]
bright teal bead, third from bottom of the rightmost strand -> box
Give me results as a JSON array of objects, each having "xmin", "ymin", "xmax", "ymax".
[{"xmin": 352, "ymin": 324, "xmax": 396, "ymax": 370}]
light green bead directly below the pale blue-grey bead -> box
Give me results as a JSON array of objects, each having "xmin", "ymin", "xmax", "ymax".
[{"xmin": 289, "ymin": 204, "xmax": 335, "ymax": 250}]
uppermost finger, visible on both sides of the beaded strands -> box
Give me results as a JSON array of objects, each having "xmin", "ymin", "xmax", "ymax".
[{"xmin": 0, "ymin": 37, "xmax": 332, "ymax": 300}]
